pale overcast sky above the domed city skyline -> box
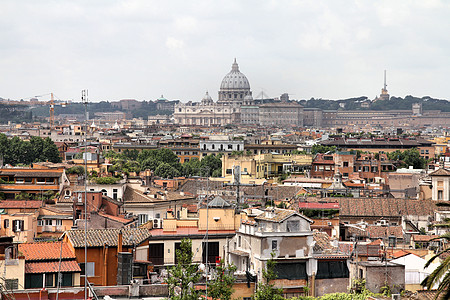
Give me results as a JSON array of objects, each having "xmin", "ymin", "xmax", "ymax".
[{"xmin": 0, "ymin": 0, "xmax": 450, "ymax": 102}]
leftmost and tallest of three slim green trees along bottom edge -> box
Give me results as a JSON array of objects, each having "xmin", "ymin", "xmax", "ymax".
[{"xmin": 166, "ymin": 238, "xmax": 201, "ymax": 300}]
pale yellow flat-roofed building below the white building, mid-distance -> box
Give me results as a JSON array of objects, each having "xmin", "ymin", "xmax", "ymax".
[{"xmin": 222, "ymin": 153, "xmax": 313, "ymax": 179}]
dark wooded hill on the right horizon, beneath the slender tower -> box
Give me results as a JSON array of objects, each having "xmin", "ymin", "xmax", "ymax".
[{"xmin": 299, "ymin": 95, "xmax": 450, "ymax": 112}]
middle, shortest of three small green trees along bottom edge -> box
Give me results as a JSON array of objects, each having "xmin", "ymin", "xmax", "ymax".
[{"xmin": 208, "ymin": 259, "xmax": 236, "ymax": 300}]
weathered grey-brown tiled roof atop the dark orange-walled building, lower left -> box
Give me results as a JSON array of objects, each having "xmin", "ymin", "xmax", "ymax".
[{"xmin": 64, "ymin": 228, "xmax": 151, "ymax": 248}]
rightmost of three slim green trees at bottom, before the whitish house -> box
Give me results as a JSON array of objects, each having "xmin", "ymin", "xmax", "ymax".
[{"xmin": 252, "ymin": 252, "xmax": 284, "ymax": 300}]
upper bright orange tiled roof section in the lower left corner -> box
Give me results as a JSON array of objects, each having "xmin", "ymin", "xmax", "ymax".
[{"xmin": 19, "ymin": 242, "xmax": 75, "ymax": 260}]
